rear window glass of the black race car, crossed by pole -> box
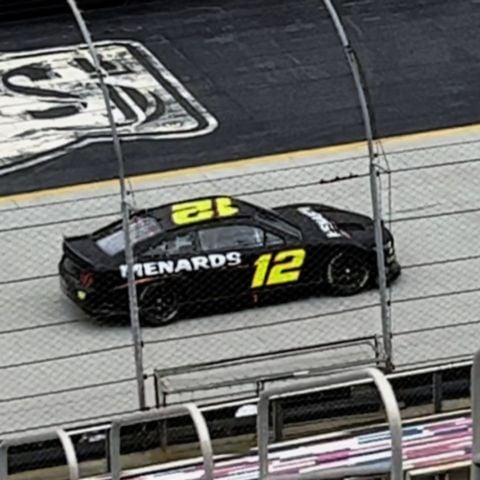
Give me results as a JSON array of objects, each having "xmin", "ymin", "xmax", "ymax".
[{"xmin": 97, "ymin": 217, "xmax": 162, "ymax": 256}]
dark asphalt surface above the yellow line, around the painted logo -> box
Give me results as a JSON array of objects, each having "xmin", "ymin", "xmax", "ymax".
[{"xmin": 0, "ymin": 0, "xmax": 480, "ymax": 194}]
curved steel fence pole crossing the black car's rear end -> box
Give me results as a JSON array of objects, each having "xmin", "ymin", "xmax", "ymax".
[{"xmin": 67, "ymin": 0, "xmax": 146, "ymax": 410}]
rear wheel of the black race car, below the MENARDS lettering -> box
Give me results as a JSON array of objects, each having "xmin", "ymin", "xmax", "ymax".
[{"xmin": 140, "ymin": 286, "xmax": 180, "ymax": 327}]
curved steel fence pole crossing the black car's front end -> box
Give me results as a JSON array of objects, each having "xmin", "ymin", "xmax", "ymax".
[{"xmin": 322, "ymin": 0, "xmax": 393, "ymax": 369}]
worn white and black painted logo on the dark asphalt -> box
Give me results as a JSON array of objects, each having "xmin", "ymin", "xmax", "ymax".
[{"xmin": 0, "ymin": 41, "xmax": 217, "ymax": 175}]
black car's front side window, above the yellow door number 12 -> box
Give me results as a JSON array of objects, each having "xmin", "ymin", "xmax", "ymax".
[{"xmin": 198, "ymin": 225, "xmax": 265, "ymax": 251}]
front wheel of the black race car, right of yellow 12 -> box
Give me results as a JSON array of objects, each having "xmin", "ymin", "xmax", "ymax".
[{"xmin": 326, "ymin": 251, "xmax": 371, "ymax": 296}]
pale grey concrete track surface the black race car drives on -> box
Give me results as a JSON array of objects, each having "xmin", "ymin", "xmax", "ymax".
[{"xmin": 0, "ymin": 127, "xmax": 480, "ymax": 436}]
